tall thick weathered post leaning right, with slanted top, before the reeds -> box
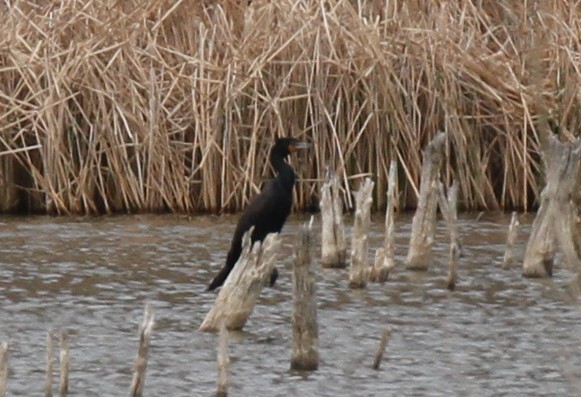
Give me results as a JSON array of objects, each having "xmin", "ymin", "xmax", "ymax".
[{"xmin": 406, "ymin": 132, "xmax": 446, "ymax": 271}]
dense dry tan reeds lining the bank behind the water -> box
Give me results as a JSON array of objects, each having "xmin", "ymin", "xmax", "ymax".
[{"xmin": 0, "ymin": 0, "xmax": 581, "ymax": 213}]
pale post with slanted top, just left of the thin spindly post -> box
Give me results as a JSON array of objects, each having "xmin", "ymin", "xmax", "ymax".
[{"xmin": 349, "ymin": 178, "xmax": 375, "ymax": 288}]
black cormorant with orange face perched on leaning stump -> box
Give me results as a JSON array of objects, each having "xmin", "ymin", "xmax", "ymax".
[{"xmin": 208, "ymin": 138, "xmax": 310, "ymax": 291}]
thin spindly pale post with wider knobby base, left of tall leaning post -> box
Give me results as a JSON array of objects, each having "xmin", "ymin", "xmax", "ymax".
[{"xmin": 369, "ymin": 160, "xmax": 397, "ymax": 282}]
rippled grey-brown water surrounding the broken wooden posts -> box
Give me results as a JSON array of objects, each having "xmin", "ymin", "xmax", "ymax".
[{"xmin": 0, "ymin": 214, "xmax": 581, "ymax": 396}]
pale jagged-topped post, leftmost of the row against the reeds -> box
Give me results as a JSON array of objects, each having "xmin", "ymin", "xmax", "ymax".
[{"xmin": 319, "ymin": 168, "xmax": 347, "ymax": 268}]
